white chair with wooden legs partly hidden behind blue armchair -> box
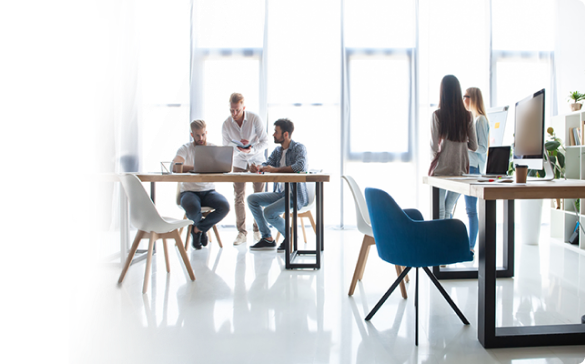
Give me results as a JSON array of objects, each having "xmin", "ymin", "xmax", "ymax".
[{"xmin": 342, "ymin": 176, "xmax": 408, "ymax": 298}]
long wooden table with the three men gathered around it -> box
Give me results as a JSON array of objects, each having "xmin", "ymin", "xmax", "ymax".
[{"xmin": 95, "ymin": 173, "xmax": 329, "ymax": 269}]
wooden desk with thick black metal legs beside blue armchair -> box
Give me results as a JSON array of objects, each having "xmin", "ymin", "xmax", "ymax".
[{"xmin": 423, "ymin": 177, "xmax": 585, "ymax": 348}]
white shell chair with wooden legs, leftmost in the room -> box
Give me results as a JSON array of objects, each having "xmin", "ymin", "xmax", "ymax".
[{"xmin": 116, "ymin": 173, "xmax": 195, "ymax": 293}]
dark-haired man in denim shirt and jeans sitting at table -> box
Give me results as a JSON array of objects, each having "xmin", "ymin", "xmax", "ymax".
[{"xmin": 248, "ymin": 119, "xmax": 309, "ymax": 252}]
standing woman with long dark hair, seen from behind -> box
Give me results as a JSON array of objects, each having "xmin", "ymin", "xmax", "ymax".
[{"xmin": 429, "ymin": 75, "xmax": 477, "ymax": 219}]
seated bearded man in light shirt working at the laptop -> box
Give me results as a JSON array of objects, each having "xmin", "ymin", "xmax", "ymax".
[{"xmin": 173, "ymin": 120, "xmax": 230, "ymax": 249}]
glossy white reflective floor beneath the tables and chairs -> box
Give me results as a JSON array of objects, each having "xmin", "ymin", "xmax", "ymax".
[{"xmin": 70, "ymin": 226, "xmax": 585, "ymax": 364}]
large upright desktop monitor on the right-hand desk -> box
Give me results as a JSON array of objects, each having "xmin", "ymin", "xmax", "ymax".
[{"xmin": 514, "ymin": 89, "xmax": 544, "ymax": 170}]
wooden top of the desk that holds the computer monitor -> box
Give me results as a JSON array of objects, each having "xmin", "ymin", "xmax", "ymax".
[{"xmin": 423, "ymin": 176, "xmax": 585, "ymax": 200}]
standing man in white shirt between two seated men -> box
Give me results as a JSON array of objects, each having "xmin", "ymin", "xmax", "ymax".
[{"xmin": 222, "ymin": 93, "xmax": 269, "ymax": 245}]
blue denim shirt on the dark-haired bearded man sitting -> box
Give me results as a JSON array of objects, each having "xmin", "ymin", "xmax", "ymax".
[{"xmin": 262, "ymin": 140, "xmax": 309, "ymax": 209}]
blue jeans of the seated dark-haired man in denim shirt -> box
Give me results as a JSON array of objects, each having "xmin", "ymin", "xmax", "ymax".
[{"xmin": 248, "ymin": 192, "xmax": 293, "ymax": 238}]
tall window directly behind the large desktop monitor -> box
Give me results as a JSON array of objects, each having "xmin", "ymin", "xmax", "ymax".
[{"xmin": 491, "ymin": 0, "xmax": 556, "ymax": 145}]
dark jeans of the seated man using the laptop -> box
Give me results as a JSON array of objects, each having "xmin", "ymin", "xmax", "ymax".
[{"xmin": 181, "ymin": 190, "xmax": 230, "ymax": 232}]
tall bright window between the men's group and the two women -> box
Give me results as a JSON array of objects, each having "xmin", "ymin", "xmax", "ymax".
[{"xmin": 344, "ymin": 0, "xmax": 416, "ymax": 162}]
